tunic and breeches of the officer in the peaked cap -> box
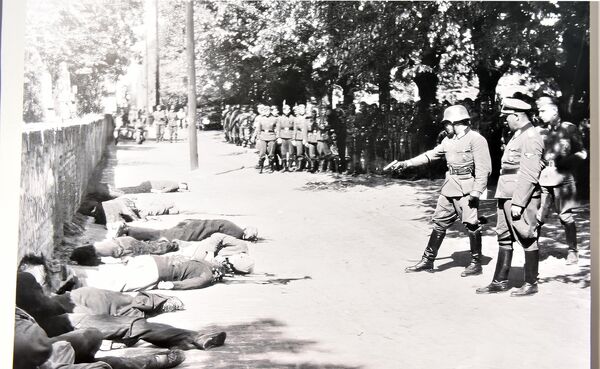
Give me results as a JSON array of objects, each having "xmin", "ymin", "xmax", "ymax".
[{"xmin": 495, "ymin": 123, "xmax": 544, "ymax": 243}]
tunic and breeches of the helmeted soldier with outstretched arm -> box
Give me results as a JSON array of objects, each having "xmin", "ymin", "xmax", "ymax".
[{"xmin": 411, "ymin": 129, "xmax": 492, "ymax": 231}]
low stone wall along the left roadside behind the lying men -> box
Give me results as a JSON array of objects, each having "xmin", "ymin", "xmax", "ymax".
[{"xmin": 18, "ymin": 115, "xmax": 114, "ymax": 261}]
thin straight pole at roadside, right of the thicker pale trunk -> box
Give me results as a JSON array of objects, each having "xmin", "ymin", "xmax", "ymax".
[{"xmin": 185, "ymin": 0, "xmax": 198, "ymax": 170}]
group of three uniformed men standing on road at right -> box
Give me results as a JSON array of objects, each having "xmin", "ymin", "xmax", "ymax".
[{"xmin": 388, "ymin": 96, "xmax": 587, "ymax": 296}]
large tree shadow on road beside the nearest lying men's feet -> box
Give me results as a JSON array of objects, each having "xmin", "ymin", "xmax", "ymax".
[{"xmin": 195, "ymin": 319, "xmax": 360, "ymax": 369}]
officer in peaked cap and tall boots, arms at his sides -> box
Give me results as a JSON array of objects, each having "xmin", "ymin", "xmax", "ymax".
[{"xmin": 477, "ymin": 98, "xmax": 544, "ymax": 296}]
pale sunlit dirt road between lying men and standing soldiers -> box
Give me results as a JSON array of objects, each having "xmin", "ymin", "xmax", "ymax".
[{"xmin": 98, "ymin": 132, "xmax": 590, "ymax": 369}]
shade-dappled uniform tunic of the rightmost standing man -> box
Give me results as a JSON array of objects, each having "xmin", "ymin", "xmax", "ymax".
[{"xmin": 538, "ymin": 122, "xmax": 584, "ymax": 223}]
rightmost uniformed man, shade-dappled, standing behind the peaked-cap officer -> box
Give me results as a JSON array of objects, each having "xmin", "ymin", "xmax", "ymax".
[{"xmin": 536, "ymin": 96, "xmax": 587, "ymax": 265}]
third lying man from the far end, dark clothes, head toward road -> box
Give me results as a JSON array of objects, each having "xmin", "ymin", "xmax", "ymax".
[{"xmin": 116, "ymin": 219, "xmax": 258, "ymax": 241}]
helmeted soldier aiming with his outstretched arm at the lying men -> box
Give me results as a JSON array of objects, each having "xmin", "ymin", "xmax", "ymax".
[{"xmin": 395, "ymin": 105, "xmax": 492, "ymax": 277}]
